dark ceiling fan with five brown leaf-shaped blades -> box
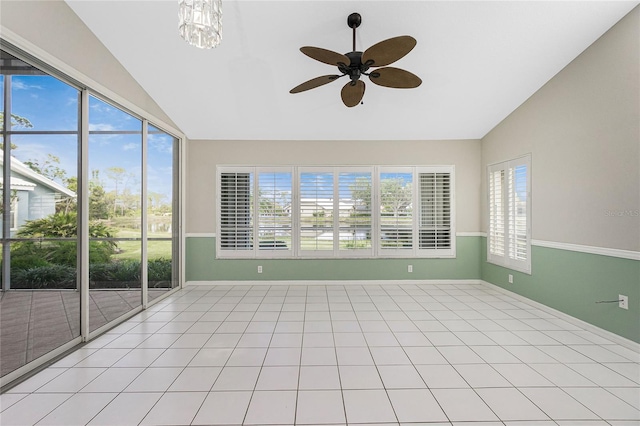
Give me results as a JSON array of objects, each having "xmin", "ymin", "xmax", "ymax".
[{"xmin": 289, "ymin": 13, "xmax": 422, "ymax": 107}]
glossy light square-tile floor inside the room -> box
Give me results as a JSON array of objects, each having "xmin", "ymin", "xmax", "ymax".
[{"xmin": 0, "ymin": 284, "xmax": 640, "ymax": 426}]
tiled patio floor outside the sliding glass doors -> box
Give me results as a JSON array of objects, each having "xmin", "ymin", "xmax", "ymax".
[{"xmin": 0, "ymin": 290, "xmax": 166, "ymax": 376}]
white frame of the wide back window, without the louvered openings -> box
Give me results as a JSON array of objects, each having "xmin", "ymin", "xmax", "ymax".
[{"xmin": 216, "ymin": 165, "xmax": 456, "ymax": 259}]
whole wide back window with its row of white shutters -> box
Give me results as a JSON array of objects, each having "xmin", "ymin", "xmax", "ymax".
[{"xmin": 217, "ymin": 166, "xmax": 455, "ymax": 258}]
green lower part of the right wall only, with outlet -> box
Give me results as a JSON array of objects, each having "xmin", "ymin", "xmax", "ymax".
[{"xmin": 481, "ymin": 238, "xmax": 640, "ymax": 343}]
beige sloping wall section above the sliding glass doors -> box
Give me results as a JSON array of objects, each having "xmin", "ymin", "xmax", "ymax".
[{"xmin": 0, "ymin": 0, "xmax": 177, "ymax": 128}]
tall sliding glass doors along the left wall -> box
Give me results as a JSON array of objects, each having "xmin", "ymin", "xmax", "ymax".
[{"xmin": 0, "ymin": 47, "xmax": 181, "ymax": 385}]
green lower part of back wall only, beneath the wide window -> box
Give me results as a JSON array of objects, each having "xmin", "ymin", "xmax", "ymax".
[{"xmin": 186, "ymin": 237, "xmax": 481, "ymax": 281}]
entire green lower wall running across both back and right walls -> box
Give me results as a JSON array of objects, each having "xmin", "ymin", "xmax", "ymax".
[{"xmin": 186, "ymin": 237, "xmax": 640, "ymax": 343}]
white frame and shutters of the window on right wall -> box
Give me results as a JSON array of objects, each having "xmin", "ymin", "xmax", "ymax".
[{"xmin": 487, "ymin": 154, "xmax": 532, "ymax": 274}]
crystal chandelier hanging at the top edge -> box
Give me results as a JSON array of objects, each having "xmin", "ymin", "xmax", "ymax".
[{"xmin": 178, "ymin": 0, "xmax": 222, "ymax": 49}]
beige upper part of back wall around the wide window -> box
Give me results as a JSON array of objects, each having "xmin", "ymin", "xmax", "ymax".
[{"xmin": 186, "ymin": 140, "xmax": 480, "ymax": 233}]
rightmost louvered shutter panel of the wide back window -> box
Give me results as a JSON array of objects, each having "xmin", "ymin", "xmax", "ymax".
[{"xmin": 418, "ymin": 172, "xmax": 455, "ymax": 250}]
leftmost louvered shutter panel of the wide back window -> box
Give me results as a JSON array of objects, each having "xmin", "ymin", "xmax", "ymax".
[{"xmin": 218, "ymin": 172, "xmax": 253, "ymax": 252}]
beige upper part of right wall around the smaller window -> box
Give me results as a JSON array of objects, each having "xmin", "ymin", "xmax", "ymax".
[{"xmin": 481, "ymin": 7, "xmax": 640, "ymax": 251}]
